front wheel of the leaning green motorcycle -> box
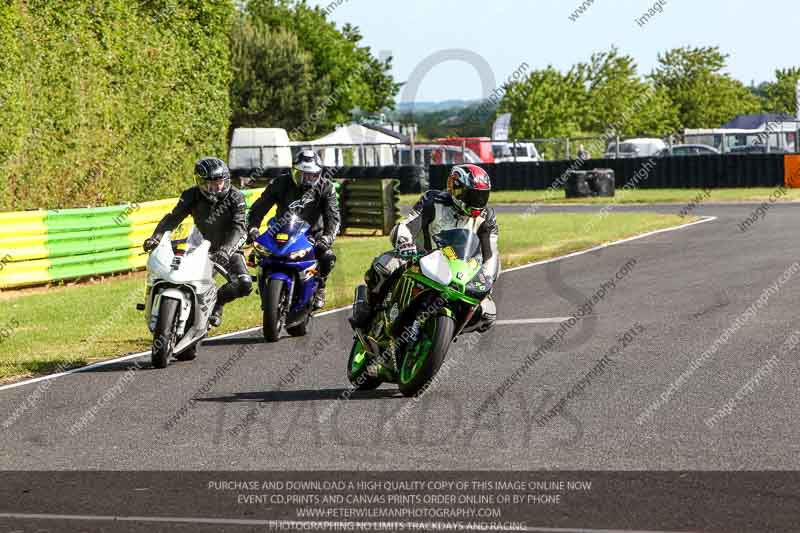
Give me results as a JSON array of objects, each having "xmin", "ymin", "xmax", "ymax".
[{"xmin": 398, "ymin": 315, "xmax": 456, "ymax": 397}]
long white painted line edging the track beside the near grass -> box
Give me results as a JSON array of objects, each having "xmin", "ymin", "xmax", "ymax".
[{"xmin": 0, "ymin": 217, "xmax": 718, "ymax": 392}]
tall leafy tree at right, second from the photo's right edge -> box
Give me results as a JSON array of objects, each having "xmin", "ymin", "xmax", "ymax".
[{"xmin": 651, "ymin": 47, "xmax": 761, "ymax": 128}]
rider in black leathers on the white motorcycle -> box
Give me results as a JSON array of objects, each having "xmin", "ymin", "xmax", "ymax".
[{"xmin": 144, "ymin": 157, "xmax": 253, "ymax": 327}]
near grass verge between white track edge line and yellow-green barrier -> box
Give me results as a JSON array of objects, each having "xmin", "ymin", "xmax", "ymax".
[{"xmin": 0, "ymin": 212, "xmax": 692, "ymax": 380}]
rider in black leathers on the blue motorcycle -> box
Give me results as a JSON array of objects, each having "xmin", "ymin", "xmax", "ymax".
[{"xmin": 247, "ymin": 150, "xmax": 341, "ymax": 309}]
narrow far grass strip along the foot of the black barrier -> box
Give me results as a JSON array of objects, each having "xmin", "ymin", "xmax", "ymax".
[{"xmin": 400, "ymin": 187, "xmax": 800, "ymax": 206}]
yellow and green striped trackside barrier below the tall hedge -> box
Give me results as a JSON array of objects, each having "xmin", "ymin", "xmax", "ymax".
[{"xmin": 0, "ymin": 189, "xmax": 269, "ymax": 289}]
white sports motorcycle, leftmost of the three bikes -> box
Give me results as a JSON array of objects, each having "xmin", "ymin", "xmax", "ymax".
[{"xmin": 137, "ymin": 228, "xmax": 227, "ymax": 368}]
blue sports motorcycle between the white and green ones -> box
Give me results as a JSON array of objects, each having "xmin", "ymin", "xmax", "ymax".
[{"xmin": 253, "ymin": 201, "xmax": 319, "ymax": 342}]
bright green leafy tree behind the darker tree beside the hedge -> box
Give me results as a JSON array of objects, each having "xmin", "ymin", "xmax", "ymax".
[{"xmin": 234, "ymin": 0, "xmax": 399, "ymax": 136}]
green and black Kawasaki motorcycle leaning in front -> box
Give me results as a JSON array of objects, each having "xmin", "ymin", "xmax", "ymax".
[{"xmin": 347, "ymin": 229, "xmax": 490, "ymax": 396}]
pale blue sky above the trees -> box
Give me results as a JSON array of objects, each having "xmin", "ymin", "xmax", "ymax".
[{"xmin": 311, "ymin": 0, "xmax": 800, "ymax": 101}]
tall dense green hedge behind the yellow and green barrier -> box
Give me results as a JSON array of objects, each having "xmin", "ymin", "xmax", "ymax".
[{"xmin": 0, "ymin": 0, "xmax": 234, "ymax": 210}]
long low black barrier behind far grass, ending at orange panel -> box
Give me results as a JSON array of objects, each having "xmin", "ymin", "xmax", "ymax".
[{"xmin": 430, "ymin": 154, "xmax": 785, "ymax": 191}]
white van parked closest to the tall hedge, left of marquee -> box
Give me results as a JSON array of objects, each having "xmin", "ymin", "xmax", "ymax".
[{"xmin": 228, "ymin": 128, "xmax": 292, "ymax": 176}]
